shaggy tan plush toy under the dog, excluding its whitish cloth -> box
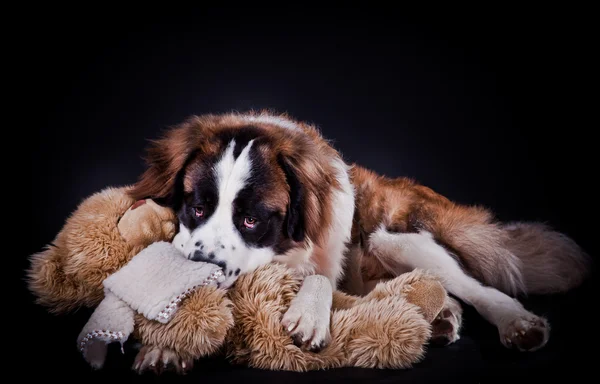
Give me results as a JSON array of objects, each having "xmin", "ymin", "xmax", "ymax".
[{"xmin": 27, "ymin": 187, "xmax": 448, "ymax": 373}]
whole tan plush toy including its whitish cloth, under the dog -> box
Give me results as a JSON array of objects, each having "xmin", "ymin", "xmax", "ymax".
[{"xmin": 27, "ymin": 187, "xmax": 448, "ymax": 371}]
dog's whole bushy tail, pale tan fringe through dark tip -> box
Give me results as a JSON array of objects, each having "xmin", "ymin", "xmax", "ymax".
[{"xmin": 426, "ymin": 206, "xmax": 591, "ymax": 295}]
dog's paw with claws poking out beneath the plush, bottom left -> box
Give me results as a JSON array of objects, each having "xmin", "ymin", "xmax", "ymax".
[{"xmin": 133, "ymin": 345, "xmax": 194, "ymax": 374}]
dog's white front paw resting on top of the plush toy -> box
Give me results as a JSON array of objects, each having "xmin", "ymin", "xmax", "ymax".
[{"xmin": 281, "ymin": 301, "xmax": 331, "ymax": 352}]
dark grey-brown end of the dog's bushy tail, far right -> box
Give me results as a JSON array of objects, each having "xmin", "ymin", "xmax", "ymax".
[{"xmin": 502, "ymin": 222, "xmax": 591, "ymax": 294}]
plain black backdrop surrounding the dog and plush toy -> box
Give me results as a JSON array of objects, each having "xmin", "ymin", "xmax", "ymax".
[{"xmin": 16, "ymin": 8, "xmax": 598, "ymax": 382}]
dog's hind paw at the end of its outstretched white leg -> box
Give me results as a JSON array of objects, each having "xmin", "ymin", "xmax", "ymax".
[{"xmin": 500, "ymin": 315, "xmax": 550, "ymax": 351}]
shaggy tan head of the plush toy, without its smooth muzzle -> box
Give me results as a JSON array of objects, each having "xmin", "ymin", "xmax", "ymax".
[{"xmin": 27, "ymin": 187, "xmax": 141, "ymax": 313}]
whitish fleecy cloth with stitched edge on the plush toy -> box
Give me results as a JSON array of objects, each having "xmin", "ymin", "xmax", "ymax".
[{"xmin": 77, "ymin": 241, "xmax": 224, "ymax": 368}]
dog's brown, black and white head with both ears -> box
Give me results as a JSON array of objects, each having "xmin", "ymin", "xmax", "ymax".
[{"xmin": 131, "ymin": 114, "xmax": 337, "ymax": 287}]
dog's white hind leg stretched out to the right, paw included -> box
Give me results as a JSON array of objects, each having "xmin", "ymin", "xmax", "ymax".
[{"xmin": 369, "ymin": 227, "xmax": 550, "ymax": 351}]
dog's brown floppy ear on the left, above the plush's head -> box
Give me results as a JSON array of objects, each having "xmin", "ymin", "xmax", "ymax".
[{"xmin": 128, "ymin": 121, "xmax": 197, "ymax": 209}]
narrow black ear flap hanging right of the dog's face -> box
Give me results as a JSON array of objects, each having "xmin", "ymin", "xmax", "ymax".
[{"xmin": 278, "ymin": 156, "xmax": 305, "ymax": 242}]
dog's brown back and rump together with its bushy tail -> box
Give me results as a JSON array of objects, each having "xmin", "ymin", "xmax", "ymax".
[{"xmin": 352, "ymin": 165, "xmax": 591, "ymax": 296}]
